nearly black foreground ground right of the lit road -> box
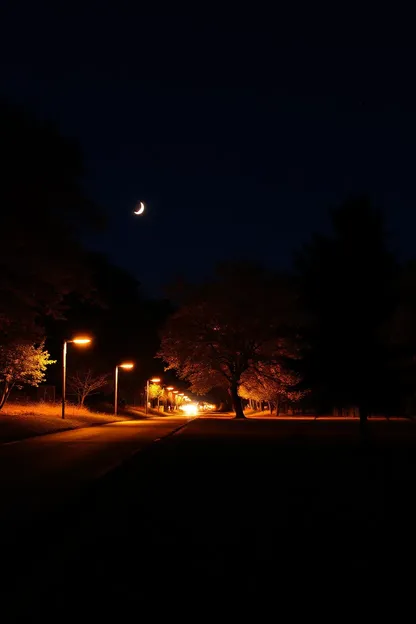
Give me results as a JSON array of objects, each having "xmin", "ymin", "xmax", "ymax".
[{"xmin": 1, "ymin": 419, "xmax": 416, "ymax": 622}]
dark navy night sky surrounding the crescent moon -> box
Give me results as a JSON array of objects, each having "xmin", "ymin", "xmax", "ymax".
[{"xmin": 0, "ymin": 1, "xmax": 416, "ymax": 292}]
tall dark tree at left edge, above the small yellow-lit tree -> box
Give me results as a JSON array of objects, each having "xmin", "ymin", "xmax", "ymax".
[{"xmin": 0, "ymin": 102, "xmax": 103, "ymax": 344}]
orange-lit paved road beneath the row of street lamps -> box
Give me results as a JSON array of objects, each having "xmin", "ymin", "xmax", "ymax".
[{"xmin": 0, "ymin": 417, "xmax": 190, "ymax": 521}]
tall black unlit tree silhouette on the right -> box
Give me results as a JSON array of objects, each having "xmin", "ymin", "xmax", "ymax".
[{"xmin": 296, "ymin": 197, "xmax": 397, "ymax": 423}]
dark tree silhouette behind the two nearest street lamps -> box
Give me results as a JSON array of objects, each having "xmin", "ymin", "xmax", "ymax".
[{"xmin": 43, "ymin": 253, "xmax": 171, "ymax": 400}]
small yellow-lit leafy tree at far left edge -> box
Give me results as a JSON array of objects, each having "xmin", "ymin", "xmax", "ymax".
[{"xmin": 0, "ymin": 342, "xmax": 56, "ymax": 409}]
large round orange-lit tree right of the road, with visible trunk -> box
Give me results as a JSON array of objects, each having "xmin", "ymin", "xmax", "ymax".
[{"xmin": 159, "ymin": 263, "xmax": 295, "ymax": 418}]
